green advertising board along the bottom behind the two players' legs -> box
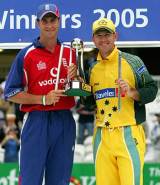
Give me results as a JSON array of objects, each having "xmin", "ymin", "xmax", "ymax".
[{"xmin": 0, "ymin": 163, "xmax": 160, "ymax": 185}]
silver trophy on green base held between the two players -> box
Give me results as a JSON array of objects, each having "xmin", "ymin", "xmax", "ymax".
[{"xmin": 65, "ymin": 38, "xmax": 92, "ymax": 96}]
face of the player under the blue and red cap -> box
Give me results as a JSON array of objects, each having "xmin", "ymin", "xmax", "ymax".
[{"xmin": 38, "ymin": 14, "xmax": 59, "ymax": 39}]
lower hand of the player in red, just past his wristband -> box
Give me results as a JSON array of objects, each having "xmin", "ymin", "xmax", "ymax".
[{"xmin": 46, "ymin": 90, "xmax": 66, "ymax": 105}]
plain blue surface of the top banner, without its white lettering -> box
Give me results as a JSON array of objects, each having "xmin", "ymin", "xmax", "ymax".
[{"xmin": 0, "ymin": 0, "xmax": 160, "ymax": 43}]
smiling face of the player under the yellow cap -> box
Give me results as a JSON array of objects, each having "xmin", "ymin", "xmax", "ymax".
[{"xmin": 93, "ymin": 31, "xmax": 117, "ymax": 55}]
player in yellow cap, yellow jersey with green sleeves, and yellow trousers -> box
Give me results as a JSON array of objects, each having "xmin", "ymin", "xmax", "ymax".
[{"xmin": 89, "ymin": 18, "xmax": 157, "ymax": 185}]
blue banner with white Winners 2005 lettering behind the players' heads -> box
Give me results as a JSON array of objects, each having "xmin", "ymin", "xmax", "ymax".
[{"xmin": 0, "ymin": 0, "xmax": 160, "ymax": 43}]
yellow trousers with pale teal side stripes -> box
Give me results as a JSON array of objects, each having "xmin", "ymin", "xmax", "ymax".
[{"xmin": 94, "ymin": 125, "xmax": 145, "ymax": 185}]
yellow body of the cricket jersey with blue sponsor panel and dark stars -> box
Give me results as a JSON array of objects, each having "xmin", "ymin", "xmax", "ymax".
[{"xmin": 90, "ymin": 47, "xmax": 136, "ymax": 127}]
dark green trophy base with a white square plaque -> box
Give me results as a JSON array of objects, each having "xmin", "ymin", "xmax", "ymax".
[{"xmin": 65, "ymin": 80, "xmax": 92, "ymax": 96}]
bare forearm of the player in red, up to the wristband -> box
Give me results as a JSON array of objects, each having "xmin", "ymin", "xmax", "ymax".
[{"xmin": 8, "ymin": 92, "xmax": 42, "ymax": 104}]
